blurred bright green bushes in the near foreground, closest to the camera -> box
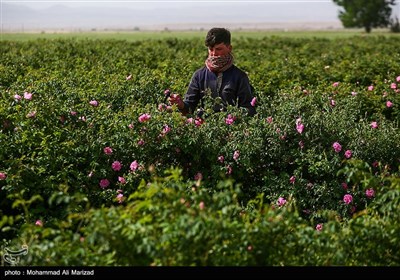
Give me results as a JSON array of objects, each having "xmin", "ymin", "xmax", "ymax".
[{"xmin": 3, "ymin": 167, "xmax": 400, "ymax": 266}]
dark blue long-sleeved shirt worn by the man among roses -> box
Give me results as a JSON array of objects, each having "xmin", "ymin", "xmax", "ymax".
[{"xmin": 183, "ymin": 65, "xmax": 256, "ymax": 116}]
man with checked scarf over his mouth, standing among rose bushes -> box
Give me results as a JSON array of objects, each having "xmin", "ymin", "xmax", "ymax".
[{"xmin": 169, "ymin": 27, "xmax": 256, "ymax": 116}]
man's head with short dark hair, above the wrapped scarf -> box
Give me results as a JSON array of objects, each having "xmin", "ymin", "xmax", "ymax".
[{"xmin": 205, "ymin": 27, "xmax": 232, "ymax": 56}]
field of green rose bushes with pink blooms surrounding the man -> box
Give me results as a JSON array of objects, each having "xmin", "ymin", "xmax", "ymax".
[{"xmin": 0, "ymin": 34, "xmax": 400, "ymax": 266}]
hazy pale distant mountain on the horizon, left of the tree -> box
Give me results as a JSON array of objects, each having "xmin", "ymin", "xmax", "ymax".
[{"xmin": 1, "ymin": 2, "xmax": 341, "ymax": 31}]
